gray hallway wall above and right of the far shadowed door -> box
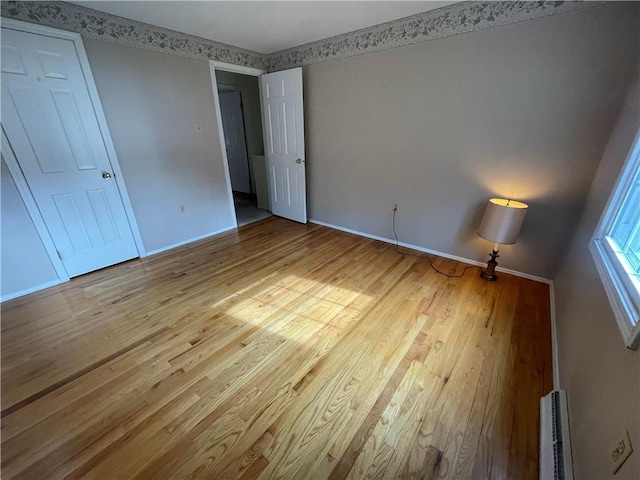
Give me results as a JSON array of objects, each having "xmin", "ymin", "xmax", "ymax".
[{"xmin": 216, "ymin": 70, "xmax": 264, "ymax": 155}]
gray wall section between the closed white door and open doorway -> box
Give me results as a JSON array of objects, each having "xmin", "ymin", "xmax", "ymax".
[{"xmin": 83, "ymin": 39, "xmax": 233, "ymax": 251}]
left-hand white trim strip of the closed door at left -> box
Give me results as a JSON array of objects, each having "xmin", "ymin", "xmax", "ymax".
[{"xmin": 2, "ymin": 128, "xmax": 69, "ymax": 282}]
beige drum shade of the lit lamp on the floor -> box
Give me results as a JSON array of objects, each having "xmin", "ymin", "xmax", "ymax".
[{"xmin": 478, "ymin": 198, "xmax": 528, "ymax": 244}]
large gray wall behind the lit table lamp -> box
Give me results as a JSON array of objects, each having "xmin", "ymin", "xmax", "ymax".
[{"xmin": 304, "ymin": 4, "xmax": 640, "ymax": 278}]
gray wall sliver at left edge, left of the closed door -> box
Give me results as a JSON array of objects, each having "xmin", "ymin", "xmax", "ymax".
[{"xmin": 0, "ymin": 158, "xmax": 58, "ymax": 298}]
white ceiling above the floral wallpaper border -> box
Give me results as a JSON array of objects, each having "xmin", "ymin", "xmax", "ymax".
[{"xmin": 72, "ymin": 0, "xmax": 457, "ymax": 53}]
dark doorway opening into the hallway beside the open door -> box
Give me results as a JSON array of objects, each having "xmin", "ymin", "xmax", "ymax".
[{"xmin": 214, "ymin": 67, "xmax": 271, "ymax": 226}]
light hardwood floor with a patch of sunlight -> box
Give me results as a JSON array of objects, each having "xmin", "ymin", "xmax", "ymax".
[{"xmin": 2, "ymin": 217, "xmax": 552, "ymax": 479}]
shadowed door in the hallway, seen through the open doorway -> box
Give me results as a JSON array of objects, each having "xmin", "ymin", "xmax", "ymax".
[{"xmin": 219, "ymin": 92, "xmax": 251, "ymax": 193}]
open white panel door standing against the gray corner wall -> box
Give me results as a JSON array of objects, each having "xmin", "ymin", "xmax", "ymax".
[{"xmin": 260, "ymin": 68, "xmax": 307, "ymax": 223}]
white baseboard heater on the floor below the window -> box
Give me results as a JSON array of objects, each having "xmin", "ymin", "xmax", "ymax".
[{"xmin": 540, "ymin": 390, "xmax": 574, "ymax": 480}]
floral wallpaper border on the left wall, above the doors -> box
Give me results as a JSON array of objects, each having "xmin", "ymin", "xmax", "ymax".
[{"xmin": 0, "ymin": 1, "xmax": 267, "ymax": 69}]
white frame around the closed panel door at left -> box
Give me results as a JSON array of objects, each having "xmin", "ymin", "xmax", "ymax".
[{"xmin": 2, "ymin": 18, "xmax": 147, "ymax": 282}]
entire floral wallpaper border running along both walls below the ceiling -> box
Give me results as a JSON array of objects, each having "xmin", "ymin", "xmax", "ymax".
[{"xmin": 0, "ymin": 1, "xmax": 615, "ymax": 71}]
